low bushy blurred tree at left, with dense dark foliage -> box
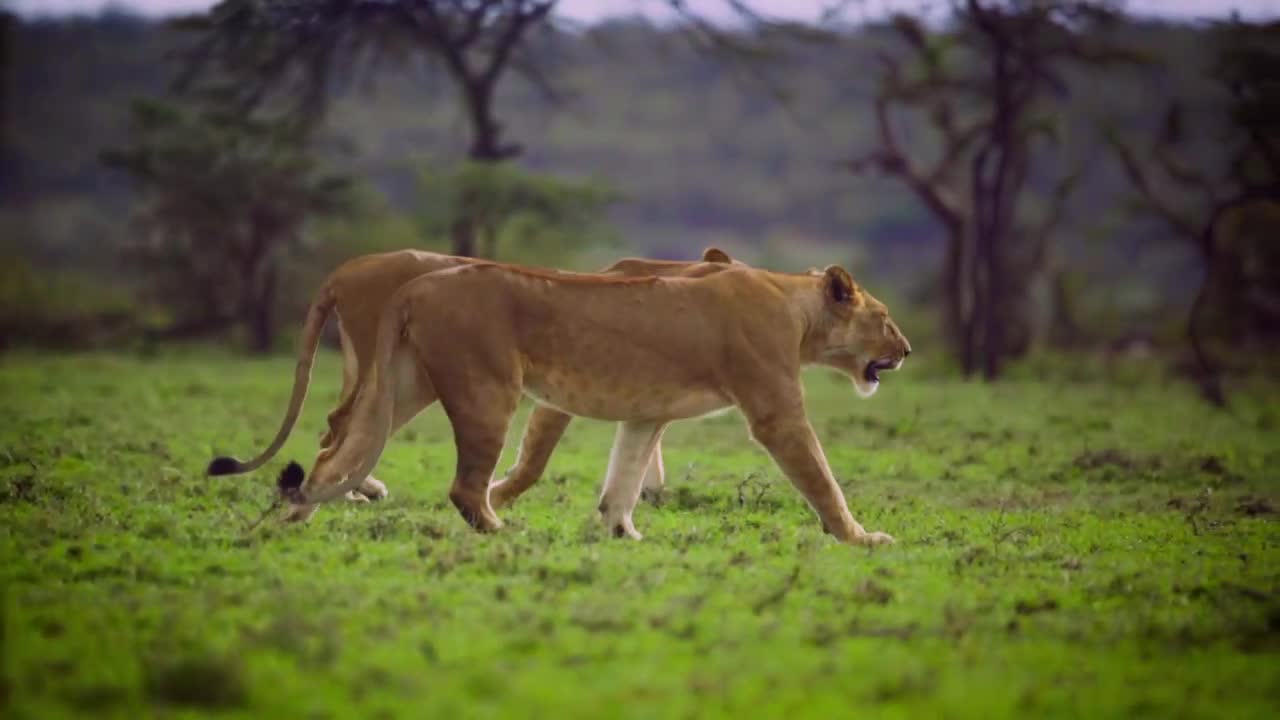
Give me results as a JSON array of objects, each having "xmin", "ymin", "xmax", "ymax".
[{"xmin": 102, "ymin": 101, "xmax": 349, "ymax": 352}]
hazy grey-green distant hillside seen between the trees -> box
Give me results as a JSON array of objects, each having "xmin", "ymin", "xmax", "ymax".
[{"xmin": 0, "ymin": 15, "xmax": 1203, "ymax": 285}]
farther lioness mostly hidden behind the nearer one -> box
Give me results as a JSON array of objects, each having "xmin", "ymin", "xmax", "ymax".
[{"xmin": 207, "ymin": 247, "xmax": 740, "ymax": 503}]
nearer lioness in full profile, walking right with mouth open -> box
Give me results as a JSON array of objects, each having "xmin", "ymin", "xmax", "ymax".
[{"xmin": 280, "ymin": 264, "xmax": 911, "ymax": 544}]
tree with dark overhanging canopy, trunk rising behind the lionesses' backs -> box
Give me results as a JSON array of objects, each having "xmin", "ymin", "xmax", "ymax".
[{"xmin": 178, "ymin": 0, "xmax": 556, "ymax": 255}]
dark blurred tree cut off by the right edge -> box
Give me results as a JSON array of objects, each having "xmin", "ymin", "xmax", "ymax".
[{"xmin": 1107, "ymin": 19, "xmax": 1280, "ymax": 406}]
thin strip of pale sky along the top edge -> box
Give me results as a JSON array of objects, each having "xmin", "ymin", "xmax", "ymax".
[{"xmin": 10, "ymin": 0, "xmax": 1280, "ymax": 22}]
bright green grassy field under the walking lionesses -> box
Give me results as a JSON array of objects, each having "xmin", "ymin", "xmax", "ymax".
[{"xmin": 0, "ymin": 352, "xmax": 1280, "ymax": 719}]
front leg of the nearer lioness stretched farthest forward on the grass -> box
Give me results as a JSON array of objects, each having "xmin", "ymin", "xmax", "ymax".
[{"xmin": 742, "ymin": 388, "xmax": 893, "ymax": 544}]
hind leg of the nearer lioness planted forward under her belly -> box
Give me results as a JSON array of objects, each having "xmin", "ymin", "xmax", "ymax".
[{"xmin": 440, "ymin": 378, "xmax": 520, "ymax": 532}]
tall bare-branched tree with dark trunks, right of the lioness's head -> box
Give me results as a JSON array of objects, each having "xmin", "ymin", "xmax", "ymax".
[{"xmin": 847, "ymin": 0, "xmax": 1135, "ymax": 379}]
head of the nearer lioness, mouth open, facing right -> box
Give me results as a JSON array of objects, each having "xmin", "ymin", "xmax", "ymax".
[{"xmin": 814, "ymin": 265, "xmax": 911, "ymax": 397}]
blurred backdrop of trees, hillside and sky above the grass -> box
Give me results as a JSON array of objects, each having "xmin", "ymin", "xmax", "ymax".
[{"xmin": 0, "ymin": 0, "xmax": 1280, "ymax": 404}]
